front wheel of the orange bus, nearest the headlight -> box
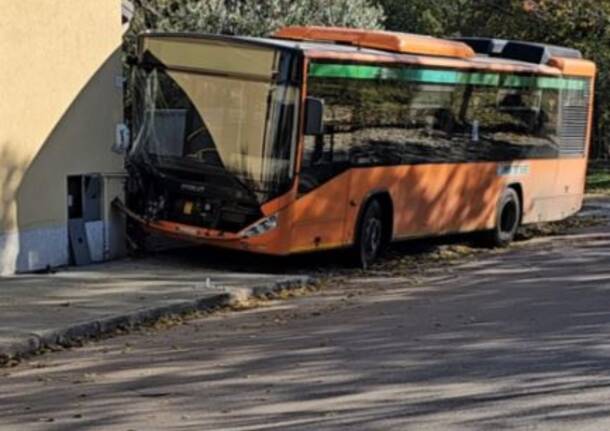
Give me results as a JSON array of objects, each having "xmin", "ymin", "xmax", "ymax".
[{"xmin": 354, "ymin": 199, "xmax": 384, "ymax": 269}]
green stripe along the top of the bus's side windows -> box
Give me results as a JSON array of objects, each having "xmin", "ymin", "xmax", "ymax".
[{"xmin": 309, "ymin": 63, "xmax": 588, "ymax": 91}]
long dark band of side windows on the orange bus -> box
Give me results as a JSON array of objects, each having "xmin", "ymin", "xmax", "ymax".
[{"xmin": 304, "ymin": 65, "xmax": 564, "ymax": 172}]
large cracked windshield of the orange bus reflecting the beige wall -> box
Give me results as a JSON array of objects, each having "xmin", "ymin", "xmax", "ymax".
[{"xmin": 131, "ymin": 44, "xmax": 298, "ymax": 203}]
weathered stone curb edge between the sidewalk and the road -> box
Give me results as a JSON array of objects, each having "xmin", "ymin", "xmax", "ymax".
[{"xmin": 0, "ymin": 276, "xmax": 317, "ymax": 367}]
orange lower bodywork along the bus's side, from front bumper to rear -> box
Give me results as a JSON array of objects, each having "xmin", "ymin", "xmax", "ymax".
[{"xmin": 141, "ymin": 158, "xmax": 586, "ymax": 255}]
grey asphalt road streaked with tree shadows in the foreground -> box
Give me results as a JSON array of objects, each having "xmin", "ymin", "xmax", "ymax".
[{"xmin": 0, "ymin": 232, "xmax": 610, "ymax": 431}]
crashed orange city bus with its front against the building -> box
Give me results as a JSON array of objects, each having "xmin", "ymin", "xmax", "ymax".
[{"xmin": 124, "ymin": 27, "xmax": 596, "ymax": 267}]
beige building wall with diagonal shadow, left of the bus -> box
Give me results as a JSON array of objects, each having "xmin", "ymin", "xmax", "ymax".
[{"xmin": 0, "ymin": 0, "xmax": 123, "ymax": 274}]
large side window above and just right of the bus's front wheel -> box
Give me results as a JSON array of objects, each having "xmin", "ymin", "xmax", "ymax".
[{"xmin": 351, "ymin": 80, "xmax": 460, "ymax": 166}]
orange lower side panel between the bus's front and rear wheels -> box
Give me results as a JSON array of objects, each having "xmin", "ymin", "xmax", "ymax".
[{"xmin": 346, "ymin": 163, "xmax": 496, "ymax": 238}]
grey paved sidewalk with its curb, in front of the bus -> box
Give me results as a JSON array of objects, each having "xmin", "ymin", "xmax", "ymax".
[{"xmin": 0, "ymin": 256, "xmax": 311, "ymax": 363}]
